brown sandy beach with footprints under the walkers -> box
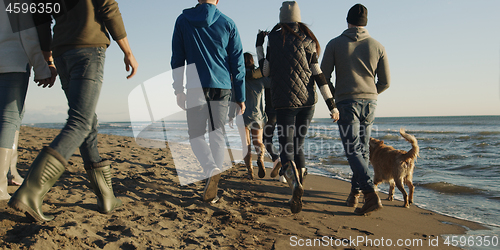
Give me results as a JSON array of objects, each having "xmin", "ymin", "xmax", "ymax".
[{"xmin": 0, "ymin": 127, "xmax": 486, "ymax": 249}]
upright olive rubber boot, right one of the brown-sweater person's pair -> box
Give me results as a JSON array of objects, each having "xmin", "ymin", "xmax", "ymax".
[{"xmin": 85, "ymin": 161, "xmax": 122, "ymax": 214}]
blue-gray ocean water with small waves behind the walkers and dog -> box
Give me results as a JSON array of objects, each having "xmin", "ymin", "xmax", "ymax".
[{"xmin": 28, "ymin": 116, "xmax": 500, "ymax": 249}]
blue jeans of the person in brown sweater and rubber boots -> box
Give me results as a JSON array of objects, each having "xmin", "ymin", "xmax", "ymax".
[{"xmin": 50, "ymin": 48, "xmax": 106, "ymax": 164}]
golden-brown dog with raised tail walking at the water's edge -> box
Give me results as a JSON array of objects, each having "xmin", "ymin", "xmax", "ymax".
[{"xmin": 370, "ymin": 128, "xmax": 419, "ymax": 208}]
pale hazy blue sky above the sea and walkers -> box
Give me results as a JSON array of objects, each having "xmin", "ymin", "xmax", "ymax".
[{"xmin": 24, "ymin": 0, "xmax": 500, "ymax": 123}]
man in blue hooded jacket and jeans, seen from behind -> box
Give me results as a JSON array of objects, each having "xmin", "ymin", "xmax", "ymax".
[{"xmin": 171, "ymin": 0, "xmax": 245, "ymax": 202}]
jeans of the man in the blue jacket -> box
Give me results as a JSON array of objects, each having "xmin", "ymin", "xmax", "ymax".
[{"xmin": 186, "ymin": 88, "xmax": 231, "ymax": 173}]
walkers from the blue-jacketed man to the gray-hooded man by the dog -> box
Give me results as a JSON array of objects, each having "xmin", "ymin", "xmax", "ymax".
[{"xmin": 171, "ymin": 0, "xmax": 390, "ymax": 215}]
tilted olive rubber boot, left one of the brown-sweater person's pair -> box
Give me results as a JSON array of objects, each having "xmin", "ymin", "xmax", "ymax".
[{"xmin": 9, "ymin": 147, "xmax": 67, "ymax": 222}]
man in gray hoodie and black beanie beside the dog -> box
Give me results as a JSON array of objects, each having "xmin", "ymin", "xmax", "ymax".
[{"xmin": 321, "ymin": 4, "xmax": 390, "ymax": 215}]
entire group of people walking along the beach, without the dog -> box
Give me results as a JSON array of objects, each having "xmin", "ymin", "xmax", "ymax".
[{"xmin": 0, "ymin": 0, "xmax": 390, "ymax": 221}]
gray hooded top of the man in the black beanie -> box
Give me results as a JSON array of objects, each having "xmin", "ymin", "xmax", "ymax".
[{"xmin": 321, "ymin": 27, "xmax": 390, "ymax": 103}]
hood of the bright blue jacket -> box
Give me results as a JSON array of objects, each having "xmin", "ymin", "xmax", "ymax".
[{"xmin": 182, "ymin": 3, "xmax": 221, "ymax": 28}]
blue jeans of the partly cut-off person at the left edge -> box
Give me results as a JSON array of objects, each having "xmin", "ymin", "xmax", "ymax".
[{"xmin": 0, "ymin": 69, "xmax": 30, "ymax": 148}]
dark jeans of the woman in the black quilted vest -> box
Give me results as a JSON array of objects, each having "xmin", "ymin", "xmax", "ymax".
[{"xmin": 276, "ymin": 106, "xmax": 314, "ymax": 172}]
